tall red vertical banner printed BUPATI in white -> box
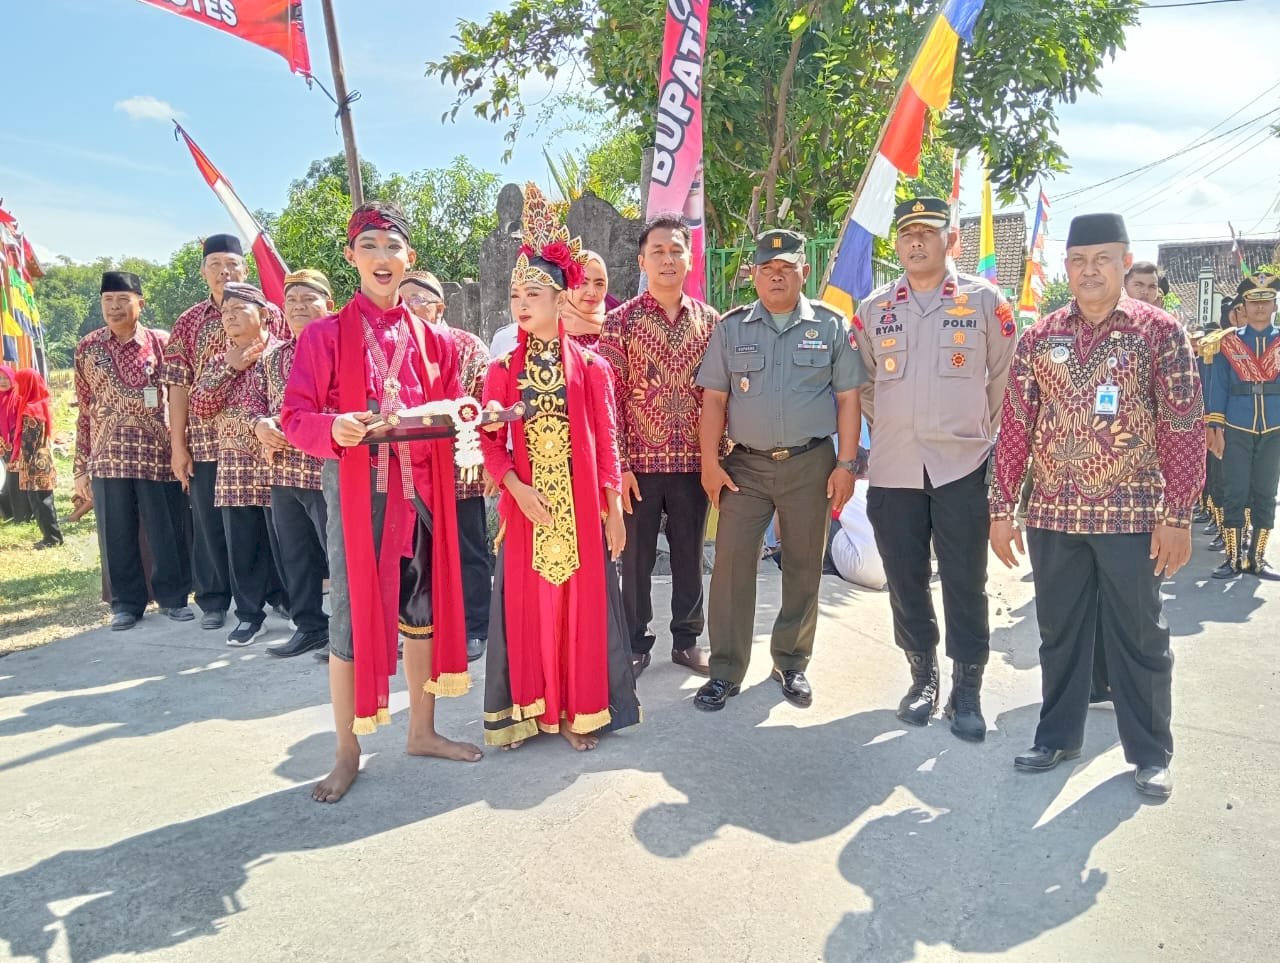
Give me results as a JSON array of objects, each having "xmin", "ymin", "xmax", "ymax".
[{"xmin": 645, "ymin": 0, "xmax": 710, "ymax": 300}]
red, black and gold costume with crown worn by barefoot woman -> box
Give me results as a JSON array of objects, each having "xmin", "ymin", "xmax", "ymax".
[{"xmin": 480, "ymin": 184, "xmax": 640, "ymax": 745}]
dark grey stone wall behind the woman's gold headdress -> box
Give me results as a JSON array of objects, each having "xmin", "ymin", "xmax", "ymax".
[{"xmin": 444, "ymin": 184, "xmax": 640, "ymax": 343}]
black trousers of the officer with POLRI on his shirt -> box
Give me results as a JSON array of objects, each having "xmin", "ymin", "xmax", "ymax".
[{"xmin": 867, "ymin": 461, "xmax": 991, "ymax": 666}]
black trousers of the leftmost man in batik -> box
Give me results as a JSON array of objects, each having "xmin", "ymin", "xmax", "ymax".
[{"xmin": 92, "ymin": 478, "xmax": 191, "ymax": 615}]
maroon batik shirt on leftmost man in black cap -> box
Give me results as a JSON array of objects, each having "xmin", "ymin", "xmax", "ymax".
[{"xmin": 74, "ymin": 324, "xmax": 174, "ymax": 482}]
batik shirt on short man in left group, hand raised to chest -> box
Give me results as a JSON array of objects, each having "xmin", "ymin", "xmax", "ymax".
[{"xmin": 191, "ymin": 337, "xmax": 279, "ymax": 508}]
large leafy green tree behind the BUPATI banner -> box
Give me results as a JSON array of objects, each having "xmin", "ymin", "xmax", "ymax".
[{"xmin": 428, "ymin": 0, "xmax": 1142, "ymax": 237}]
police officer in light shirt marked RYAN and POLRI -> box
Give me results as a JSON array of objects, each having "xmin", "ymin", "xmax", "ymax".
[{"xmin": 849, "ymin": 197, "xmax": 1018, "ymax": 741}]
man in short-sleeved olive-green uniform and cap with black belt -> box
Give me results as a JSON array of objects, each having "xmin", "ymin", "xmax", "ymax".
[{"xmin": 694, "ymin": 231, "xmax": 867, "ymax": 712}]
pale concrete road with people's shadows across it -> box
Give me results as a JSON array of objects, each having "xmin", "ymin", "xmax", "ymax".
[{"xmin": 0, "ymin": 535, "xmax": 1280, "ymax": 963}]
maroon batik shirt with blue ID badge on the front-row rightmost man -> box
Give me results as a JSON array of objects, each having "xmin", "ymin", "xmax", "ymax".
[{"xmin": 991, "ymin": 297, "xmax": 1204, "ymax": 534}]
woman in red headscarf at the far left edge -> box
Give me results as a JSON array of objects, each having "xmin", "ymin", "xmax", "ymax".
[{"xmin": 0, "ymin": 366, "xmax": 63, "ymax": 551}]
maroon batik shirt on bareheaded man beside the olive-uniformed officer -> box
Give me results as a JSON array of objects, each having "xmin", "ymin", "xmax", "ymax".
[{"xmin": 596, "ymin": 291, "xmax": 721, "ymax": 474}]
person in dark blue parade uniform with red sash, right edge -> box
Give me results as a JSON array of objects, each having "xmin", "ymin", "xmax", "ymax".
[{"xmin": 1204, "ymin": 271, "xmax": 1280, "ymax": 581}]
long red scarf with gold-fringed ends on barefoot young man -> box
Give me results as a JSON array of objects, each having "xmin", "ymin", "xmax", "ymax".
[{"xmin": 338, "ymin": 295, "xmax": 471, "ymax": 734}]
